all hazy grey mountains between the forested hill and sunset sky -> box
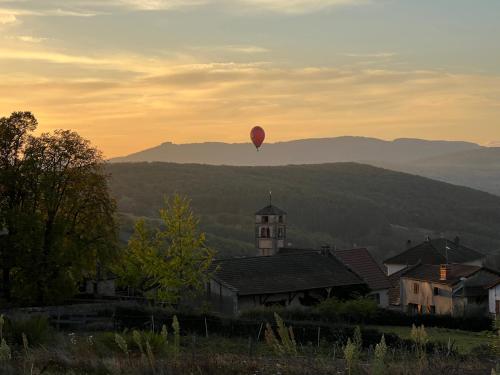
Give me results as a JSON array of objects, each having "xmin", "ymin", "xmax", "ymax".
[{"xmin": 110, "ymin": 137, "xmax": 500, "ymax": 195}]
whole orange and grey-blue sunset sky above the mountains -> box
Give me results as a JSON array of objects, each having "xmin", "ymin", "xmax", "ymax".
[{"xmin": 0, "ymin": 0, "xmax": 500, "ymax": 157}]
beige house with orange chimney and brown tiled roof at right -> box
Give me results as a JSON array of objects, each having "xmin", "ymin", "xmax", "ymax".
[{"xmin": 400, "ymin": 264, "xmax": 498, "ymax": 316}]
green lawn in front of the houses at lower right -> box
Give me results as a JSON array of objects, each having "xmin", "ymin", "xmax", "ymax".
[{"xmin": 368, "ymin": 326, "xmax": 494, "ymax": 354}]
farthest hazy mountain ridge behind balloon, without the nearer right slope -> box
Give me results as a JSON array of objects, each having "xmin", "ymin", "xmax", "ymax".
[{"xmin": 110, "ymin": 137, "xmax": 481, "ymax": 166}]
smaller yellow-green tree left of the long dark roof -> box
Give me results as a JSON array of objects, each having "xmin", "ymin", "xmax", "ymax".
[{"xmin": 116, "ymin": 195, "xmax": 214, "ymax": 304}]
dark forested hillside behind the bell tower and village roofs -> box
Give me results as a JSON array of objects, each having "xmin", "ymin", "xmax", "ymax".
[{"xmin": 108, "ymin": 163, "xmax": 500, "ymax": 264}]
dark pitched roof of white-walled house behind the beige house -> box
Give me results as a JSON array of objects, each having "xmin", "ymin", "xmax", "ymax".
[{"xmin": 384, "ymin": 238, "xmax": 484, "ymax": 265}]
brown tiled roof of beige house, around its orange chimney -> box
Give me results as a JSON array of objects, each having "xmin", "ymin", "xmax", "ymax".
[{"xmin": 401, "ymin": 264, "xmax": 482, "ymax": 285}]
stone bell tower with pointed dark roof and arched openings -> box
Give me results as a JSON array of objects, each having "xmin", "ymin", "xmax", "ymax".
[{"xmin": 255, "ymin": 193, "xmax": 286, "ymax": 256}]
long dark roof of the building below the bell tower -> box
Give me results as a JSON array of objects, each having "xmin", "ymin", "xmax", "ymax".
[{"xmin": 212, "ymin": 253, "xmax": 365, "ymax": 295}]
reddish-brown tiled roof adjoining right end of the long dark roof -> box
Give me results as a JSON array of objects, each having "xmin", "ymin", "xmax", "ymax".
[{"xmin": 334, "ymin": 248, "xmax": 391, "ymax": 290}]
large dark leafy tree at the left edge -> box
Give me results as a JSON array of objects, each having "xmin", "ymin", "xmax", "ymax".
[{"xmin": 0, "ymin": 112, "xmax": 116, "ymax": 304}]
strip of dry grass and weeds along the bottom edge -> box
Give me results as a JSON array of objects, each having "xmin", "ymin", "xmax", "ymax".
[{"xmin": 0, "ymin": 334, "xmax": 494, "ymax": 375}]
